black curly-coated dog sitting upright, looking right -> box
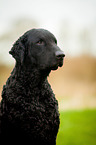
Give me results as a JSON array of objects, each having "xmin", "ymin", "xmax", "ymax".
[{"xmin": 0, "ymin": 29, "xmax": 65, "ymax": 145}]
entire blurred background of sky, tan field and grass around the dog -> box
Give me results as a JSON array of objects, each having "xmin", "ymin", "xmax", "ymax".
[{"xmin": 0, "ymin": 0, "xmax": 96, "ymax": 145}]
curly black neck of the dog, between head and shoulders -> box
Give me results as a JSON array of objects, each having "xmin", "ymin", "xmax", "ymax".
[{"xmin": 13, "ymin": 65, "xmax": 50, "ymax": 88}]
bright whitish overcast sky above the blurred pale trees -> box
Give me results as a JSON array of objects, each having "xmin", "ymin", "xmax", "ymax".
[{"xmin": 0, "ymin": 0, "xmax": 96, "ymax": 63}]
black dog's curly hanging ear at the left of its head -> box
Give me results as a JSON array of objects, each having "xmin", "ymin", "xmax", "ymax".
[{"xmin": 9, "ymin": 36, "xmax": 25, "ymax": 64}]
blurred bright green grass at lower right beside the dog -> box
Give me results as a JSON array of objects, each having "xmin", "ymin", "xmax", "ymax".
[{"xmin": 57, "ymin": 110, "xmax": 96, "ymax": 145}]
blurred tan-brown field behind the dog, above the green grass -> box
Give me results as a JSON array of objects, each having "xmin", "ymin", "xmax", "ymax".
[{"xmin": 0, "ymin": 56, "xmax": 96, "ymax": 110}]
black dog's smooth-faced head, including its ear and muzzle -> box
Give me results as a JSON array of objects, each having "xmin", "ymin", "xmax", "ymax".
[{"xmin": 9, "ymin": 29, "xmax": 65, "ymax": 70}]
